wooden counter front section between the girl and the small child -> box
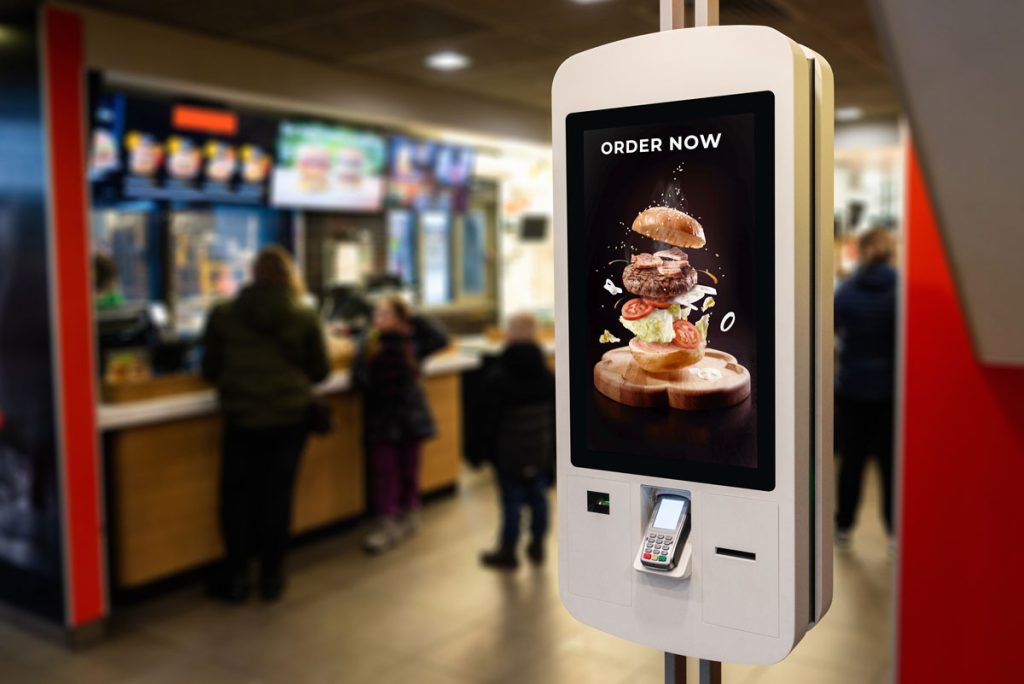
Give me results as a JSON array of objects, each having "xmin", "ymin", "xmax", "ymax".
[{"xmin": 420, "ymin": 374, "xmax": 462, "ymax": 491}]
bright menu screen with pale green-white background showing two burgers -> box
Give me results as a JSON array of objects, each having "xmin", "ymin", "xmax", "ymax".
[{"xmin": 271, "ymin": 121, "xmax": 387, "ymax": 212}]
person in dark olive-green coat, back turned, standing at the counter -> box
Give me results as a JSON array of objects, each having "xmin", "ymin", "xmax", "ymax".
[{"xmin": 203, "ymin": 246, "xmax": 330, "ymax": 602}]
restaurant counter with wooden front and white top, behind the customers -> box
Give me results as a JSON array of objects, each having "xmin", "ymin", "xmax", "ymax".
[{"xmin": 98, "ymin": 353, "xmax": 480, "ymax": 589}]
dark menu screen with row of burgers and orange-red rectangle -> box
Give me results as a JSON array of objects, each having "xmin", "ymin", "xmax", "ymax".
[{"xmin": 89, "ymin": 92, "xmax": 276, "ymax": 205}]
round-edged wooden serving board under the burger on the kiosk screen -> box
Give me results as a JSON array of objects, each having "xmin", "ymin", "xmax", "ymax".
[{"xmin": 594, "ymin": 347, "xmax": 751, "ymax": 411}]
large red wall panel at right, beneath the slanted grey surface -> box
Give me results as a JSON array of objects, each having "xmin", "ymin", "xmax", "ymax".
[{"xmin": 897, "ymin": 151, "xmax": 1024, "ymax": 684}]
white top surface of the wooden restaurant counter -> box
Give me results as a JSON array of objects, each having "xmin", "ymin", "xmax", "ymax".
[{"xmin": 97, "ymin": 353, "xmax": 480, "ymax": 431}]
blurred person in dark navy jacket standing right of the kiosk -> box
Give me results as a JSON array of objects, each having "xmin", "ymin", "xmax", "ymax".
[{"xmin": 836, "ymin": 227, "xmax": 897, "ymax": 550}]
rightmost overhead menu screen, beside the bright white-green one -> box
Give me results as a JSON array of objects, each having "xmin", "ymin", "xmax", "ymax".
[{"xmin": 388, "ymin": 135, "xmax": 475, "ymax": 211}]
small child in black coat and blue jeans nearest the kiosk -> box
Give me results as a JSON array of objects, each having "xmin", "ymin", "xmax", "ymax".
[{"xmin": 475, "ymin": 313, "xmax": 555, "ymax": 569}]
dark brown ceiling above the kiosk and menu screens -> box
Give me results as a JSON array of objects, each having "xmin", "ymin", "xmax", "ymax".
[{"xmin": 70, "ymin": 0, "xmax": 899, "ymax": 116}]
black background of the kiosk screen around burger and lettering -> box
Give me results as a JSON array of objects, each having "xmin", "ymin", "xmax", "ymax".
[{"xmin": 568, "ymin": 93, "xmax": 774, "ymax": 488}]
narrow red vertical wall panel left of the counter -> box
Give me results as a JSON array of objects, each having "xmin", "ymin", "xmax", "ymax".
[{"xmin": 43, "ymin": 7, "xmax": 106, "ymax": 628}]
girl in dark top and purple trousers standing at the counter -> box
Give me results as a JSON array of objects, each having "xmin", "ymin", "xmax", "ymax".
[{"xmin": 352, "ymin": 296, "xmax": 449, "ymax": 553}]
